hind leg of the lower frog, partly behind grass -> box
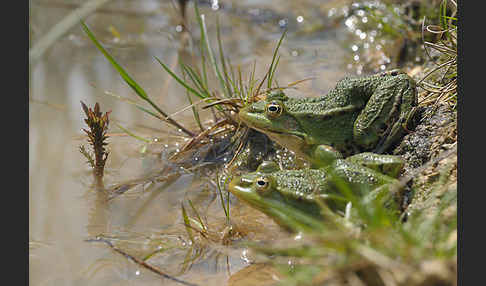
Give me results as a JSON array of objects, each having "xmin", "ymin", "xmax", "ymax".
[{"xmin": 346, "ymin": 152, "xmax": 405, "ymax": 178}]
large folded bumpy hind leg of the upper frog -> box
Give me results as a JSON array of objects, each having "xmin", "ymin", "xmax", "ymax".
[{"xmin": 353, "ymin": 73, "xmax": 417, "ymax": 153}]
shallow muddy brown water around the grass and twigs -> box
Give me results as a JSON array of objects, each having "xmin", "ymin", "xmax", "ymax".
[{"xmin": 29, "ymin": 0, "xmax": 364, "ymax": 285}]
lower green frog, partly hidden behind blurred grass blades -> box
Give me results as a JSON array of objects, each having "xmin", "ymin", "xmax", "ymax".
[{"xmin": 229, "ymin": 153, "xmax": 403, "ymax": 230}]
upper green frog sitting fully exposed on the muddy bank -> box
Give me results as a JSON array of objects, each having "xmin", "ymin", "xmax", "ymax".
[{"xmin": 238, "ymin": 70, "xmax": 417, "ymax": 168}]
